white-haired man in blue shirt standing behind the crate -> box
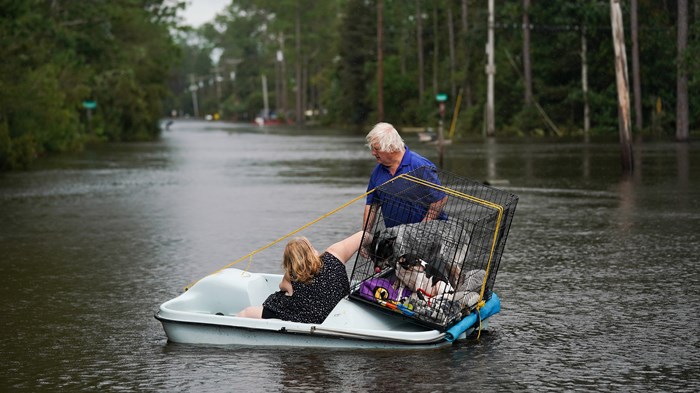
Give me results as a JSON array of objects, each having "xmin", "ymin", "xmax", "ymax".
[{"xmin": 362, "ymin": 123, "xmax": 447, "ymax": 228}]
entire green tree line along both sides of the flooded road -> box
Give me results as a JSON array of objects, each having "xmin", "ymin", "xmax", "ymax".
[{"xmin": 0, "ymin": 0, "xmax": 700, "ymax": 169}]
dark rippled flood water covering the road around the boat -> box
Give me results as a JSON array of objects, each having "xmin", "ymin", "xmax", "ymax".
[{"xmin": 0, "ymin": 121, "xmax": 700, "ymax": 392}]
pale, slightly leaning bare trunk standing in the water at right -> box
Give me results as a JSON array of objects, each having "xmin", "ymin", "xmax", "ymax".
[{"xmin": 610, "ymin": 0, "xmax": 634, "ymax": 174}]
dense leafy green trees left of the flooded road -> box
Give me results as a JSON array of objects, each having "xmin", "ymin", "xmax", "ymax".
[{"xmin": 0, "ymin": 0, "xmax": 184, "ymax": 170}]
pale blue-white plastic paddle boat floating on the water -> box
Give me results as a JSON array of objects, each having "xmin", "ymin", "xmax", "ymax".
[{"xmin": 155, "ymin": 268, "xmax": 500, "ymax": 348}]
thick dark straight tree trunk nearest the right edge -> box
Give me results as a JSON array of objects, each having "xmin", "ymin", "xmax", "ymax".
[{"xmin": 676, "ymin": 0, "xmax": 689, "ymax": 142}]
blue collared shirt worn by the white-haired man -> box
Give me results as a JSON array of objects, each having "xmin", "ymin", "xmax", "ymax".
[{"xmin": 366, "ymin": 147, "xmax": 447, "ymax": 228}]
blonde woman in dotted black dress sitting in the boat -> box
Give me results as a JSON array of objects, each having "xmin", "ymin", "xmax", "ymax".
[{"xmin": 238, "ymin": 231, "xmax": 363, "ymax": 323}]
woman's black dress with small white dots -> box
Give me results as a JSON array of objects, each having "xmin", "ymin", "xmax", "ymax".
[{"xmin": 263, "ymin": 252, "xmax": 350, "ymax": 323}]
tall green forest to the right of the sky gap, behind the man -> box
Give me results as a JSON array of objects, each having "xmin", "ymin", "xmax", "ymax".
[{"xmin": 170, "ymin": 0, "xmax": 700, "ymax": 139}]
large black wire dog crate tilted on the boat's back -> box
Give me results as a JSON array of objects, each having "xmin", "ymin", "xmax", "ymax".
[{"xmin": 350, "ymin": 167, "xmax": 518, "ymax": 331}]
